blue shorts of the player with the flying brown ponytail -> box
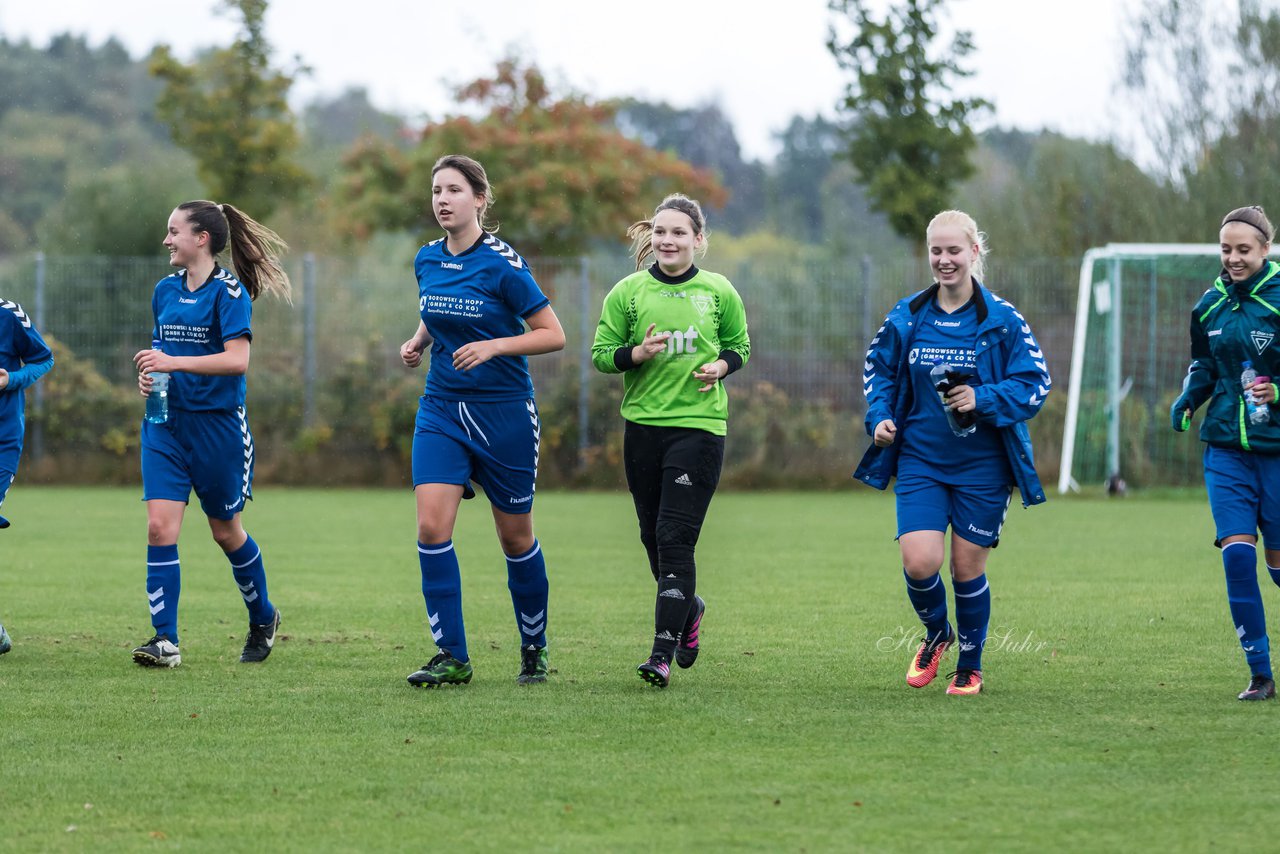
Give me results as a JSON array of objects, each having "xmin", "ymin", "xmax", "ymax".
[{"xmin": 142, "ymin": 407, "xmax": 253, "ymax": 520}]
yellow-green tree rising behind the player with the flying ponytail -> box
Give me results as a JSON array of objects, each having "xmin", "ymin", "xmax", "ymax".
[{"xmin": 150, "ymin": 0, "xmax": 308, "ymax": 218}]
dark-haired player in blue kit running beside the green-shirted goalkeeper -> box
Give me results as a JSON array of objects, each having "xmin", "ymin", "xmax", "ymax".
[{"xmin": 401, "ymin": 155, "xmax": 564, "ymax": 688}]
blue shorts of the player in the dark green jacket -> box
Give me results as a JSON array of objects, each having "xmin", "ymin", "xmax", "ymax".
[{"xmin": 1204, "ymin": 444, "xmax": 1280, "ymax": 549}]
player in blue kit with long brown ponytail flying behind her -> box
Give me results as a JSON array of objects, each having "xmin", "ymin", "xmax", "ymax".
[{"xmin": 133, "ymin": 201, "xmax": 289, "ymax": 667}]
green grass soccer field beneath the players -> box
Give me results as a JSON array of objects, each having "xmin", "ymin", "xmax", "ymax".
[{"xmin": 0, "ymin": 484, "xmax": 1280, "ymax": 851}]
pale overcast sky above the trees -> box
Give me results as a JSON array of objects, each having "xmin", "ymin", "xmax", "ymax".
[{"xmin": 0, "ymin": 0, "xmax": 1132, "ymax": 157}]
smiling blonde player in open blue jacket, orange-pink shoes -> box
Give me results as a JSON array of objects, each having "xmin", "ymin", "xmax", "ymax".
[{"xmin": 854, "ymin": 210, "xmax": 1050, "ymax": 695}]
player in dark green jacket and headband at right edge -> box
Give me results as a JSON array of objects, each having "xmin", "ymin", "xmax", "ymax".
[{"xmin": 1170, "ymin": 206, "xmax": 1280, "ymax": 700}]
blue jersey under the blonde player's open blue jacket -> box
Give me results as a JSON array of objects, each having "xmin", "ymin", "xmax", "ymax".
[{"xmin": 899, "ymin": 301, "xmax": 1014, "ymax": 485}]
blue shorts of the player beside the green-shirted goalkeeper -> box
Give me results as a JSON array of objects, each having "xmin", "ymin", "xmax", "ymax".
[{"xmin": 413, "ymin": 394, "xmax": 541, "ymax": 513}]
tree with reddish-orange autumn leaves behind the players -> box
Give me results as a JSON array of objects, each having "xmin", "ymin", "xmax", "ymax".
[{"xmin": 342, "ymin": 59, "xmax": 727, "ymax": 256}]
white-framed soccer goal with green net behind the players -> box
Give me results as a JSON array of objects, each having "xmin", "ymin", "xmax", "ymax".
[{"xmin": 1057, "ymin": 243, "xmax": 1259, "ymax": 493}]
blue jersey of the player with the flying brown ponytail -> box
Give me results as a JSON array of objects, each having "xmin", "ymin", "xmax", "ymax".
[{"xmin": 151, "ymin": 268, "xmax": 253, "ymax": 411}]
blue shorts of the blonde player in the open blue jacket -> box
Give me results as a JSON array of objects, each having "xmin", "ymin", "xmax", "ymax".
[{"xmin": 893, "ymin": 475, "xmax": 1014, "ymax": 548}]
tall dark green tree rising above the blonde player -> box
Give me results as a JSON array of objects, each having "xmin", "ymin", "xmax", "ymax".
[{"xmin": 827, "ymin": 0, "xmax": 988, "ymax": 241}]
